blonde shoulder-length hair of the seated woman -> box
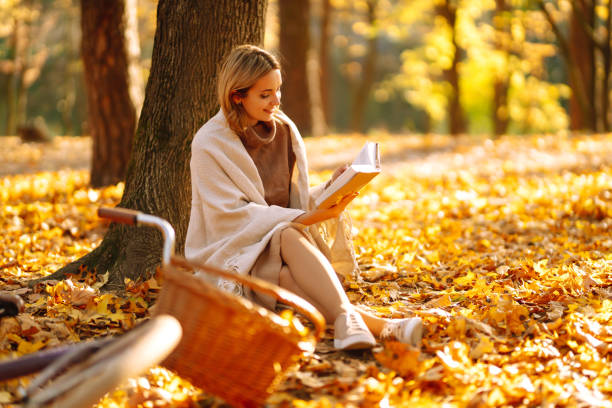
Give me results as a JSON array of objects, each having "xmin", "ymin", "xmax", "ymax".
[{"xmin": 217, "ymin": 44, "xmax": 280, "ymax": 133}]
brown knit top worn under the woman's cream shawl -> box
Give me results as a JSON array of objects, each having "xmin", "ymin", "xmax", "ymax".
[{"xmin": 239, "ymin": 120, "xmax": 295, "ymax": 207}]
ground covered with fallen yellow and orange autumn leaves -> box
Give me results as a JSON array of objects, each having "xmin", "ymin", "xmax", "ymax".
[{"xmin": 0, "ymin": 135, "xmax": 612, "ymax": 407}]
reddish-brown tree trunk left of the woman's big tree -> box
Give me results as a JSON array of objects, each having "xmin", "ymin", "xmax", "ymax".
[{"xmin": 81, "ymin": 0, "xmax": 136, "ymax": 187}]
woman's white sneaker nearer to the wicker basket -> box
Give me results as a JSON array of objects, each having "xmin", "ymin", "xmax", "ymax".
[{"xmin": 334, "ymin": 312, "xmax": 376, "ymax": 350}]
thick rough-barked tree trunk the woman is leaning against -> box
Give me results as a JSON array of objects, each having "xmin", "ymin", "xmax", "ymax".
[{"xmin": 47, "ymin": 0, "xmax": 266, "ymax": 289}]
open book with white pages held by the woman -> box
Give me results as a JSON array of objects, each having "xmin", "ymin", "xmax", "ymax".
[{"xmin": 315, "ymin": 142, "xmax": 380, "ymax": 208}]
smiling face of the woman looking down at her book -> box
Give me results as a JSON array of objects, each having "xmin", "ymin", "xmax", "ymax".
[{"xmin": 234, "ymin": 69, "xmax": 283, "ymax": 126}]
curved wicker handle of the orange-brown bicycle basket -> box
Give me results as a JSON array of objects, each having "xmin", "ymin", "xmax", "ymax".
[{"xmin": 171, "ymin": 256, "xmax": 325, "ymax": 341}]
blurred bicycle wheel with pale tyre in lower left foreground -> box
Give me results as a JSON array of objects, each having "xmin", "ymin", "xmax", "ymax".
[{"xmin": 24, "ymin": 315, "xmax": 182, "ymax": 408}]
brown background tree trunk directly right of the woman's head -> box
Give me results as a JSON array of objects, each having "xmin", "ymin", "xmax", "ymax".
[{"xmin": 278, "ymin": 0, "xmax": 312, "ymax": 136}]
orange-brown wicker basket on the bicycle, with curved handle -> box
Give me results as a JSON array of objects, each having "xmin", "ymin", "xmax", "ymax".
[{"xmin": 155, "ymin": 257, "xmax": 325, "ymax": 406}]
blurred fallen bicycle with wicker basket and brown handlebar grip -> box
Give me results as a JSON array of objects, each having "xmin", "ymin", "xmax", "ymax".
[{"xmin": 0, "ymin": 208, "xmax": 325, "ymax": 408}]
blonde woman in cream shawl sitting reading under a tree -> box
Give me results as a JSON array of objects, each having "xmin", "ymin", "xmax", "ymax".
[{"xmin": 185, "ymin": 45, "xmax": 422, "ymax": 349}]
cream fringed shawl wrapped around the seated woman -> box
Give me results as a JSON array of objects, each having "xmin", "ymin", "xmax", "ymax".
[{"xmin": 185, "ymin": 111, "xmax": 357, "ymax": 293}]
